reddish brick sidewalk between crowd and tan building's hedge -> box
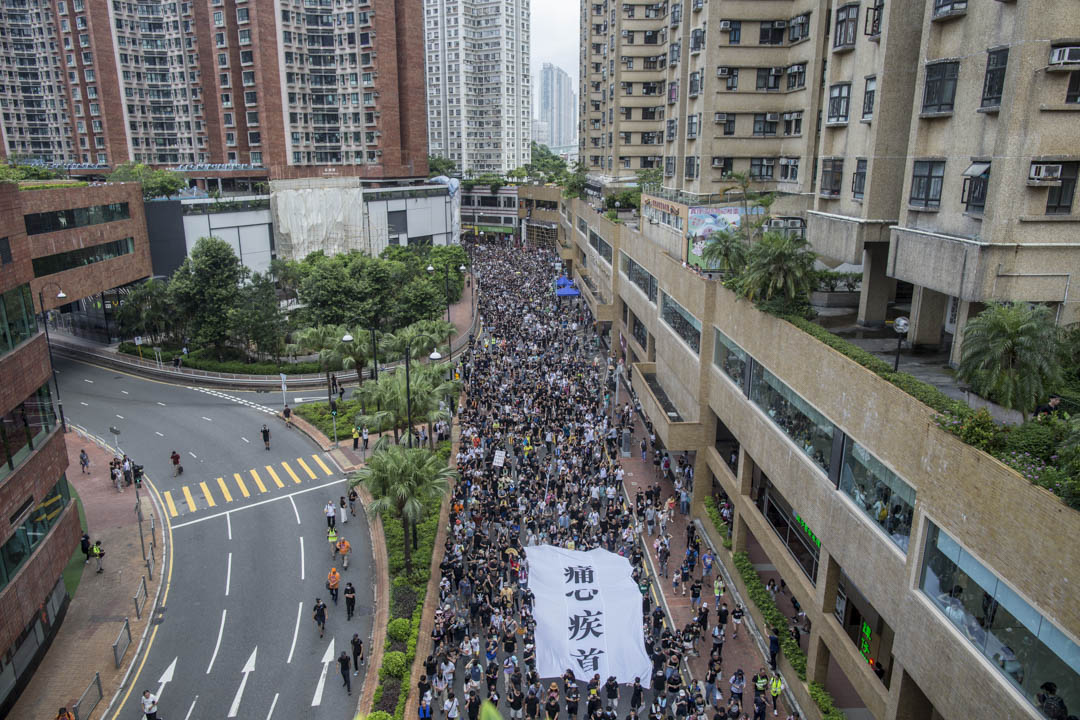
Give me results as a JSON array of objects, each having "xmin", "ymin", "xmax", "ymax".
[{"xmin": 618, "ymin": 384, "xmax": 791, "ymax": 717}]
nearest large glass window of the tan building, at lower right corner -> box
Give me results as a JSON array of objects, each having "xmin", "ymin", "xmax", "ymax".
[{"xmin": 920, "ymin": 522, "xmax": 1080, "ymax": 709}]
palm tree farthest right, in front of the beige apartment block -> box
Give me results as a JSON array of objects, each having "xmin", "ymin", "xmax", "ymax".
[{"xmin": 958, "ymin": 302, "xmax": 1063, "ymax": 420}]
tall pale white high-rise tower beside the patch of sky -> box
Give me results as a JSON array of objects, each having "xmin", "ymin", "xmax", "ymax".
[{"xmin": 422, "ymin": 0, "xmax": 532, "ymax": 177}]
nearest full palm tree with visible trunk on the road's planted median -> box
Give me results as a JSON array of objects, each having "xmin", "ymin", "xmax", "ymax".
[{"xmin": 349, "ymin": 438, "xmax": 457, "ymax": 574}]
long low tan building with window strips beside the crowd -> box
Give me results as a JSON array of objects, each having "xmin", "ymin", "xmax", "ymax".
[{"xmin": 537, "ymin": 181, "xmax": 1080, "ymax": 720}]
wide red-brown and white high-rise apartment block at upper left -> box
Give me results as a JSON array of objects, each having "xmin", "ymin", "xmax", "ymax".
[{"xmin": 0, "ymin": 0, "xmax": 428, "ymax": 183}]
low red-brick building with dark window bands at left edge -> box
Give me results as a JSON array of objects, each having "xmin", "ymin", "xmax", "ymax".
[{"xmin": 0, "ymin": 185, "xmax": 123, "ymax": 715}]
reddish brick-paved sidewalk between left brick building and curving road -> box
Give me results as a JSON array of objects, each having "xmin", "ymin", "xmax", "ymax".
[{"xmin": 11, "ymin": 432, "xmax": 162, "ymax": 720}]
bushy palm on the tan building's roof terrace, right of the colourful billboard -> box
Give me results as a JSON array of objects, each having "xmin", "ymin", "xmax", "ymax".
[{"xmin": 740, "ymin": 232, "xmax": 816, "ymax": 307}]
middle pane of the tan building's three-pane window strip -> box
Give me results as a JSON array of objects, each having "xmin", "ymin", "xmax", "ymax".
[{"xmin": 750, "ymin": 363, "xmax": 835, "ymax": 475}]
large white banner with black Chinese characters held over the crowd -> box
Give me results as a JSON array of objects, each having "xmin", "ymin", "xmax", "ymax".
[{"xmin": 526, "ymin": 545, "xmax": 652, "ymax": 688}]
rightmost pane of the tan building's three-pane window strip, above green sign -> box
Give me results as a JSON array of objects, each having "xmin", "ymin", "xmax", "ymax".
[{"xmin": 840, "ymin": 437, "xmax": 915, "ymax": 553}]
